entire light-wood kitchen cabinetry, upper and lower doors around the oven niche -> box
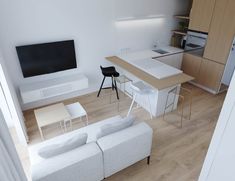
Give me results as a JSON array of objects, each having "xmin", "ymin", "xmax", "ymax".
[{"xmin": 182, "ymin": 0, "xmax": 235, "ymax": 93}]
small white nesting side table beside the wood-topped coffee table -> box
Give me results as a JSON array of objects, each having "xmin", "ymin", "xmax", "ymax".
[{"xmin": 65, "ymin": 102, "xmax": 88, "ymax": 130}]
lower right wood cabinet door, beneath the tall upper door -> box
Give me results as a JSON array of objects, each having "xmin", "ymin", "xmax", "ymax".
[{"xmin": 197, "ymin": 58, "xmax": 225, "ymax": 92}]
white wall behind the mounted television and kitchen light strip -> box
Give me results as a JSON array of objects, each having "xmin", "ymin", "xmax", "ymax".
[{"xmin": 0, "ymin": 0, "xmax": 188, "ymax": 108}]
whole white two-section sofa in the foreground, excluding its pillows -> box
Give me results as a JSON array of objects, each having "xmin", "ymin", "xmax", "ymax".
[{"xmin": 29, "ymin": 116, "xmax": 153, "ymax": 181}]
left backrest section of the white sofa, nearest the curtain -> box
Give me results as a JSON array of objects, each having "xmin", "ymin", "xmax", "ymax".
[{"xmin": 32, "ymin": 143, "xmax": 104, "ymax": 181}]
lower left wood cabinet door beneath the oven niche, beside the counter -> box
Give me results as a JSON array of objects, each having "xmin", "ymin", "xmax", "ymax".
[{"xmin": 182, "ymin": 53, "xmax": 202, "ymax": 82}]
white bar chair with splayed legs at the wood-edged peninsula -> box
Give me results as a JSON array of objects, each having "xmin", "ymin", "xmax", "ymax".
[{"xmin": 127, "ymin": 81, "xmax": 154, "ymax": 119}]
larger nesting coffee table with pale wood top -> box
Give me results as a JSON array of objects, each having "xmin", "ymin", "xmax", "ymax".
[{"xmin": 34, "ymin": 103, "xmax": 71, "ymax": 139}]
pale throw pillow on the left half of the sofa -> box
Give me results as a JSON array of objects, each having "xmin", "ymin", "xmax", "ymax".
[{"xmin": 38, "ymin": 133, "xmax": 88, "ymax": 158}]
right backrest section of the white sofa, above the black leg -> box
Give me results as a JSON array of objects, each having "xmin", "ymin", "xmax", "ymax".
[{"xmin": 97, "ymin": 122, "xmax": 153, "ymax": 177}]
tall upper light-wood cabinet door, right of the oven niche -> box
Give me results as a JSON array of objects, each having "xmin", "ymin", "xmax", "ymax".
[{"xmin": 204, "ymin": 0, "xmax": 235, "ymax": 64}]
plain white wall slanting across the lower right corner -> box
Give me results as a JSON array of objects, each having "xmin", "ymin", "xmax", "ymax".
[{"xmin": 199, "ymin": 69, "xmax": 235, "ymax": 181}]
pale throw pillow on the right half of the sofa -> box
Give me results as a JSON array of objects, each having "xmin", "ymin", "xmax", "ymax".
[{"xmin": 97, "ymin": 116, "xmax": 135, "ymax": 139}]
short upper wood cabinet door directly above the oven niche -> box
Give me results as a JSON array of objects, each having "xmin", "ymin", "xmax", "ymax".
[{"xmin": 189, "ymin": 0, "xmax": 216, "ymax": 33}]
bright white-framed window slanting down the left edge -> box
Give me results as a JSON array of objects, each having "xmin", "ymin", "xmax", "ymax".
[{"xmin": 0, "ymin": 64, "xmax": 29, "ymax": 178}]
